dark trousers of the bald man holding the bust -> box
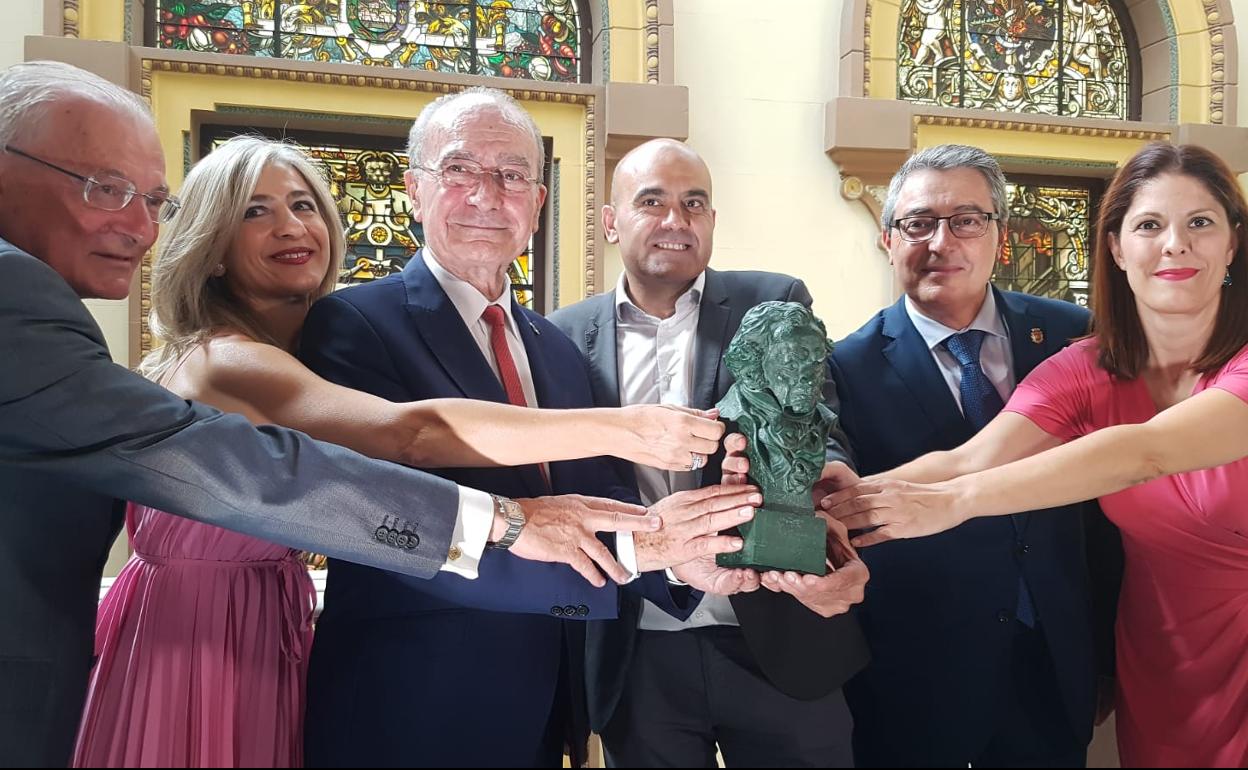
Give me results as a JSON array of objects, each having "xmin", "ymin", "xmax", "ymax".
[{"xmin": 602, "ymin": 626, "xmax": 852, "ymax": 768}]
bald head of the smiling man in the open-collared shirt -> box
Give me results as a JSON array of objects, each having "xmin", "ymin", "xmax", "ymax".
[{"xmin": 603, "ymin": 139, "xmax": 715, "ymax": 302}]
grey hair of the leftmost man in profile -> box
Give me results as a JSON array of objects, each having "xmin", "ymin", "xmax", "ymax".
[{"xmin": 0, "ymin": 61, "xmax": 152, "ymax": 147}]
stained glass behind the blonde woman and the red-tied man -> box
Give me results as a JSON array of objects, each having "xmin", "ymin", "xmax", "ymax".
[{"xmin": 203, "ymin": 126, "xmax": 544, "ymax": 311}]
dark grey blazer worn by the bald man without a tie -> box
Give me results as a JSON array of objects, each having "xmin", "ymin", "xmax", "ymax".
[{"xmin": 550, "ymin": 270, "xmax": 867, "ymax": 731}]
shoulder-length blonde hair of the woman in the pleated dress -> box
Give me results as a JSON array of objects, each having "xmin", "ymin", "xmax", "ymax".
[{"xmin": 139, "ymin": 136, "xmax": 347, "ymax": 381}]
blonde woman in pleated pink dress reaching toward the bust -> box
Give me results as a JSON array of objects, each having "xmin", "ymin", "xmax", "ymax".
[{"xmin": 74, "ymin": 137, "xmax": 741, "ymax": 768}]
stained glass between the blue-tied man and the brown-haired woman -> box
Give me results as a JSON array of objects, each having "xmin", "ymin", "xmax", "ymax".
[{"xmin": 992, "ymin": 183, "xmax": 1092, "ymax": 307}]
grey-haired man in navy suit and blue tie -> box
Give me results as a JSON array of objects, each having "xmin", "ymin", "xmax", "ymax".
[{"xmin": 831, "ymin": 145, "xmax": 1123, "ymax": 768}]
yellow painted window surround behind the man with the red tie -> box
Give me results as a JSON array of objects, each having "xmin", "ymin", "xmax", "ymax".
[{"xmin": 152, "ymin": 71, "xmax": 585, "ymax": 309}]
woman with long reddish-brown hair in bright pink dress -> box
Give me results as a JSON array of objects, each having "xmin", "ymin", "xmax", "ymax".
[{"xmin": 825, "ymin": 145, "xmax": 1248, "ymax": 768}]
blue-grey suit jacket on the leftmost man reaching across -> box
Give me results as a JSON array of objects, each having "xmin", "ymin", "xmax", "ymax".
[{"xmin": 0, "ymin": 240, "xmax": 459, "ymax": 768}]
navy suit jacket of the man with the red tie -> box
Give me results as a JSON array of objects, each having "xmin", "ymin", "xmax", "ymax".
[{"xmin": 301, "ymin": 256, "xmax": 675, "ymax": 766}]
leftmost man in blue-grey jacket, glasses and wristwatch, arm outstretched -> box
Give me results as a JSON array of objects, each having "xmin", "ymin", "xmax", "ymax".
[{"xmin": 0, "ymin": 62, "xmax": 658, "ymax": 766}]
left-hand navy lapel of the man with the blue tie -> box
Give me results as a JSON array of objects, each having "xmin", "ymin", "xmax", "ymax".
[{"xmin": 882, "ymin": 297, "xmax": 971, "ymax": 443}]
